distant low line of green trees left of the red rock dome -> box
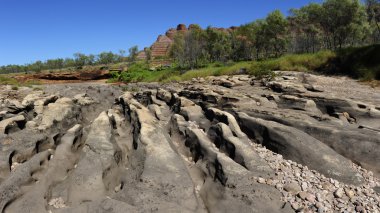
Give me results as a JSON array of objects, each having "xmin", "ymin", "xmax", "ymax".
[{"xmin": 0, "ymin": 46, "xmax": 138, "ymax": 73}]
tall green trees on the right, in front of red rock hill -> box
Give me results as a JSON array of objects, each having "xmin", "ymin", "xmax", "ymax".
[{"xmin": 171, "ymin": 0, "xmax": 380, "ymax": 68}]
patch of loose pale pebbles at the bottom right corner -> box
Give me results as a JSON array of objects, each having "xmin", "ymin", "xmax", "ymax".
[{"xmin": 249, "ymin": 131, "xmax": 380, "ymax": 213}]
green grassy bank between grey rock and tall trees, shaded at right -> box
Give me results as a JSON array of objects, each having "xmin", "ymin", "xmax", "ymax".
[{"xmin": 109, "ymin": 45, "xmax": 380, "ymax": 82}]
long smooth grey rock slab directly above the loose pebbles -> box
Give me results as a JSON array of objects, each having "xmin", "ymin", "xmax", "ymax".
[{"xmin": 238, "ymin": 113, "xmax": 362, "ymax": 184}]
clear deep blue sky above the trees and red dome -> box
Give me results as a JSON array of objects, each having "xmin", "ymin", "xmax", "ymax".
[{"xmin": 0, "ymin": 0, "xmax": 322, "ymax": 65}]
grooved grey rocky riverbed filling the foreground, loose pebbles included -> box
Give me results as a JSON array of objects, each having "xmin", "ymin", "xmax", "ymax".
[{"xmin": 0, "ymin": 72, "xmax": 380, "ymax": 212}]
